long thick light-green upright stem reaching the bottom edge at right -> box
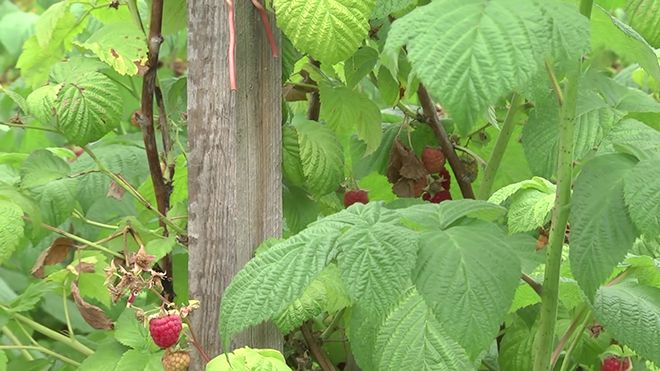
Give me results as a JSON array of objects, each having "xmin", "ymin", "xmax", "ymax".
[{"xmin": 534, "ymin": 64, "xmax": 580, "ymax": 371}]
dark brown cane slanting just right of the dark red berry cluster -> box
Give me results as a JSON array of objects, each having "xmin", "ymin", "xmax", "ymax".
[{"xmin": 417, "ymin": 84, "xmax": 474, "ymax": 198}]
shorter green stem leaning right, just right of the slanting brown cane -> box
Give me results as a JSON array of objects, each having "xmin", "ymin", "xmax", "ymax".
[{"xmin": 477, "ymin": 93, "xmax": 524, "ymax": 200}]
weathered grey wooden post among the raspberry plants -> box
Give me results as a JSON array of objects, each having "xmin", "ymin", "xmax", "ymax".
[{"xmin": 188, "ymin": 0, "xmax": 282, "ymax": 370}]
